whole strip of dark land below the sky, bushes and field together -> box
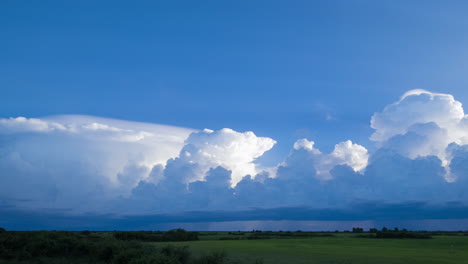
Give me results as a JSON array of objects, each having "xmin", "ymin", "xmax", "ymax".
[{"xmin": 0, "ymin": 228, "xmax": 468, "ymax": 264}]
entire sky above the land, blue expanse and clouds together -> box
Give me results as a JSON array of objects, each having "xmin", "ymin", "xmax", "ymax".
[{"xmin": 0, "ymin": 0, "xmax": 468, "ymax": 229}]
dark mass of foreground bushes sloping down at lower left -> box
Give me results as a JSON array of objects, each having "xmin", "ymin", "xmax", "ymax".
[{"xmin": 0, "ymin": 231, "xmax": 190, "ymax": 264}]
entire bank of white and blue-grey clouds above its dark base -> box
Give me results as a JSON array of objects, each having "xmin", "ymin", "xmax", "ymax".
[{"xmin": 0, "ymin": 90, "xmax": 468, "ymax": 214}]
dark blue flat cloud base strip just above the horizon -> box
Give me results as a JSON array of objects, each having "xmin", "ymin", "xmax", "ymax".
[{"xmin": 0, "ymin": 202, "xmax": 468, "ymax": 231}]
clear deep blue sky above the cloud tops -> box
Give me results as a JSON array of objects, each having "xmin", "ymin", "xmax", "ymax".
[{"xmin": 0, "ymin": 0, "xmax": 468, "ymax": 161}]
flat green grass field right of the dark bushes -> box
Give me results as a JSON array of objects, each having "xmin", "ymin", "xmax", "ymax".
[{"xmin": 165, "ymin": 234, "xmax": 468, "ymax": 264}]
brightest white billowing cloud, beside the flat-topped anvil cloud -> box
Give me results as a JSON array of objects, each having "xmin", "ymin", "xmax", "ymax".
[{"xmin": 173, "ymin": 128, "xmax": 276, "ymax": 185}]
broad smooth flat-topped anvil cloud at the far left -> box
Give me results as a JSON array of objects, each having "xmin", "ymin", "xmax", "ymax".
[{"xmin": 0, "ymin": 116, "xmax": 195, "ymax": 209}]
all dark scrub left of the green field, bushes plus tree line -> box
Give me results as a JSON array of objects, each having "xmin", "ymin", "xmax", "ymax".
[{"xmin": 0, "ymin": 229, "xmax": 270, "ymax": 264}]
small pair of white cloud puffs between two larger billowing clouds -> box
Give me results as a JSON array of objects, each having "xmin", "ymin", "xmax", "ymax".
[{"xmin": 286, "ymin": 139, "xmax": 369, "ymax": 180}]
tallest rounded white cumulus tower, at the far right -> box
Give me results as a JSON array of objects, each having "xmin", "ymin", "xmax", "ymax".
[{"xmin": 371, "ymin": 90, "xmax": 468, "ymax": 181}]
